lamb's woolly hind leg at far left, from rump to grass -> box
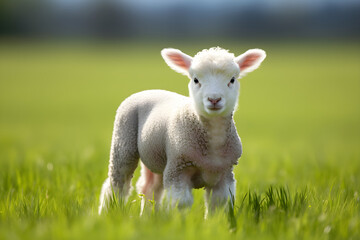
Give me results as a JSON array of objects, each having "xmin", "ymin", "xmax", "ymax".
[{"xmin": 99, "ymin": 109, "xmax": 139, "ymax": 214}]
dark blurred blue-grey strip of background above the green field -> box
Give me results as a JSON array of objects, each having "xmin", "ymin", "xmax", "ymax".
[{"xmin": 0, "ymin": 0, "xmax": 360, "ymax": 41}]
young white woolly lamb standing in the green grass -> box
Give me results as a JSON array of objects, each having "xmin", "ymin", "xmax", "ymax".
[{"xmin": 99, "ymin": 47, "xmax": 266, "ymax": 214}]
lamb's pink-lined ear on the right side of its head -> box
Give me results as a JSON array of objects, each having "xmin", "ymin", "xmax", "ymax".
[{"xmin": 235, "ymin": 49, "xmax": 266, "ymax": 76}]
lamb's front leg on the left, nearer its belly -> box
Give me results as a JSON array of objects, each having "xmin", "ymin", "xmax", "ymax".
[{"xmin": 163, "ymin": 164, "xmax": 194, "ymax": 209}]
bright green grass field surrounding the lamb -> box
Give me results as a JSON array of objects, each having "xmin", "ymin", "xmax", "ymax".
[{"xmin": 0, "ymin": 42, "xmax": 360, "ymax": 239}]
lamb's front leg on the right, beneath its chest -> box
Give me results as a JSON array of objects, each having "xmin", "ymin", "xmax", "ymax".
[{"xmin": 205, "ymin": 169, "xmax": 236, "ymax": 218}]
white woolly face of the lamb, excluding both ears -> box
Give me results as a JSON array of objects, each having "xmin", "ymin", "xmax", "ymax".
[{"xmin": 189, "ymin": 49, "xmax": 240, "ymax": 117}]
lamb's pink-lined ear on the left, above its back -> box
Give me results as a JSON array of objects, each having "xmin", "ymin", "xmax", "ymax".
[{"xmin": 161, "ymin": 48, "xmax": 192, "ymax": 75}]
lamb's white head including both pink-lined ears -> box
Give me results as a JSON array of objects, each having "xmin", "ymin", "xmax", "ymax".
[{"xmin": 161, "ymin": 47, "xmax": 266, "ymax": 117}]
